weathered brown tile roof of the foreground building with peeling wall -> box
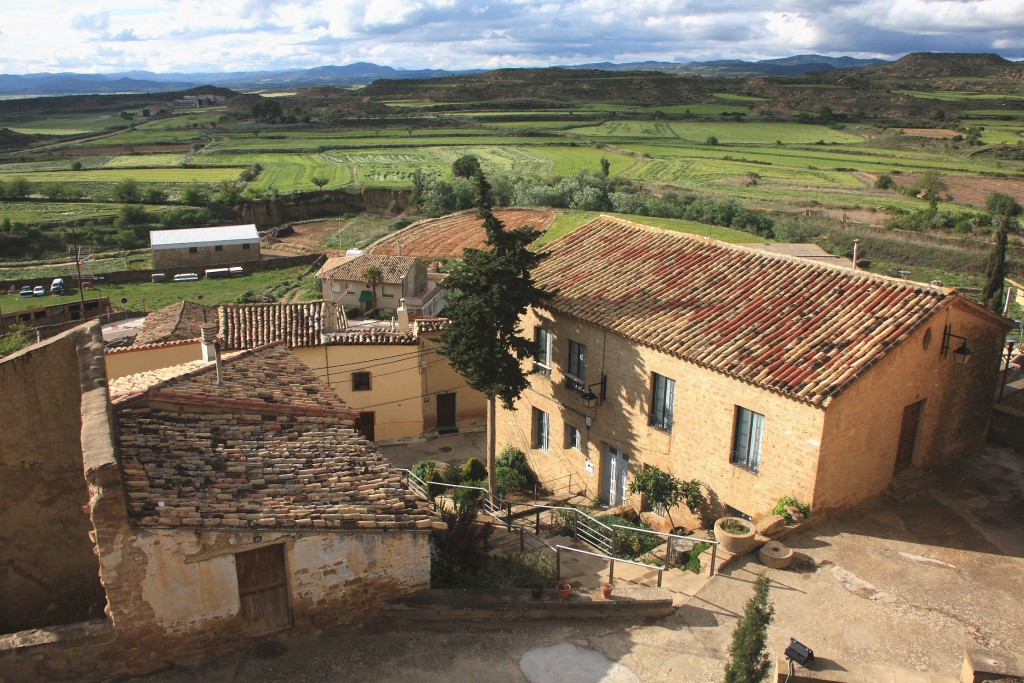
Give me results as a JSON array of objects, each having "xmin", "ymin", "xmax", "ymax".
[{"xmin": 116, "ymin": 347, "xmax": 435, "ymax": 529}]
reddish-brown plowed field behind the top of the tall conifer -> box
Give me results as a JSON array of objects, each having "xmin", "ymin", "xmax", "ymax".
[{"xmin": 370, "ymin": 209, "xmax": 555, "ymax": 259}]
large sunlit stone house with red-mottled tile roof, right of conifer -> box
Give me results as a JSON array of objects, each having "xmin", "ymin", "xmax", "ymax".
[{"xmin": 497, "ymin": 216, "xmax": 1010, "ymax": 516}]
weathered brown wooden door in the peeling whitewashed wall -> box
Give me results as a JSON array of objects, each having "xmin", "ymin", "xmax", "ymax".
[{"xmin": 234, "ymin": 545, "xmax": 292, "ymax": 635}]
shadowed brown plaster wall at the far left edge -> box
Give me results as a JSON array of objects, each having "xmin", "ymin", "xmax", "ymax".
[{"xmin": 0, "ymin": 324, "xmax": 103, "ymax": 633}]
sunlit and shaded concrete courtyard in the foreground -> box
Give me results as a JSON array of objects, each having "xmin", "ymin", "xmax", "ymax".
[{"xmin": 134, "ymin": 446, "xmax": 1024, "ymax": 683}]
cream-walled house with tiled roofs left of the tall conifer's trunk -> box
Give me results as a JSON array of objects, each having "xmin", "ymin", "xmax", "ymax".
[{"xmin": 105, "ymin": 301, "xmax": 486, "ymax": 441}]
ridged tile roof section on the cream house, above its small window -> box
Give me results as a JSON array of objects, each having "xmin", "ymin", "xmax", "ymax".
[{"xmin": 217, "ymin": 301, "xmax": 324, "ymax": 349}]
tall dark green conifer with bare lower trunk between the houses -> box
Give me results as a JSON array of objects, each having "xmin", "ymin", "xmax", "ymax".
[{"xmin": 438, "ymin": 172, "xmax": 551, "ymax": 496}]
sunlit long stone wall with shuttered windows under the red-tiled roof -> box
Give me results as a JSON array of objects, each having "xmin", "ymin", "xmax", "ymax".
[{"xmin": 497, "ymin": 311, "xmax": 823, "ymax": 515}]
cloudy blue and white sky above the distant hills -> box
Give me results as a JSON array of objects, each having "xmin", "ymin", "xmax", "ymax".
[{"xmin": 0, "ymin": 0, "xmax": 1024, "ymax": 74}]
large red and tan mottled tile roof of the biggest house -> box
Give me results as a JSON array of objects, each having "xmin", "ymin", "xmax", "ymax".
[{"xmin": 534, "ymin": 216, "xmax": 973, "ymax": 405}]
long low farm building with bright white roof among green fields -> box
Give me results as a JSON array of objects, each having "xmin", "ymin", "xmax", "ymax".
[{"xmin": 150, "ymin": 224, "xmax": 260, "ymax": 274}]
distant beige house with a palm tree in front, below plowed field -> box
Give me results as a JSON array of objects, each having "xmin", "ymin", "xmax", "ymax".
[{"xmin": 317, "ymin": 254, "xmax": 444, "ymax": 316}]
